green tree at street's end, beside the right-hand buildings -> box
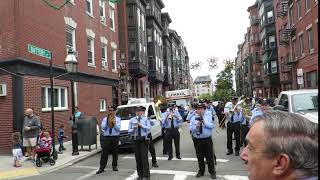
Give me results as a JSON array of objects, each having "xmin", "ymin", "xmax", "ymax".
[{"xmin": 213, "ymin": 59, "xmax": 235, "ymax": 101}]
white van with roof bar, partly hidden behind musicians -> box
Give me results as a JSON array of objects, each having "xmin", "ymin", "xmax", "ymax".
[{"xmin": 116, "ymin": 102, "xmax": 161, "ymax": 148}]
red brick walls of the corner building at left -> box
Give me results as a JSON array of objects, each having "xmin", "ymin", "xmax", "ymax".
[{"xmin": 0, "ymin": 0, "xmax": 120, "ymax": 154}]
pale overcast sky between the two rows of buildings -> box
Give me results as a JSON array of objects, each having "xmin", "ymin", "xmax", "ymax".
[{"xmin": 162, "ymin": 0, "xmax": 255, "ymax": 84}]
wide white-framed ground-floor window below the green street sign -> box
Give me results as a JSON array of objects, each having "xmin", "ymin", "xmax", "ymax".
[{"xmin": 41, "ymin": 87, "xmax": 68, "ymax": 111}]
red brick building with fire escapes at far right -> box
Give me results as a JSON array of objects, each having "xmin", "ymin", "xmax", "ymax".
[{"xmin": 274, "ymin": 0, "xmax": 318, "ymax": 90}]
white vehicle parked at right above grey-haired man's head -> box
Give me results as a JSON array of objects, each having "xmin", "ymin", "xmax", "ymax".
[{"xmin": 274, "ymin": 89, "xmax": 318, "ymax": 123}]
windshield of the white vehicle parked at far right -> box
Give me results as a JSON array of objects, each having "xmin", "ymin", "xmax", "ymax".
[{"xmin": 292, "ymin": 93, "xmax": 318, "ymax": 112}]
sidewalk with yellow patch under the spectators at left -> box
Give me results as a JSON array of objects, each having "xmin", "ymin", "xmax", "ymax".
[{"xmin": 0, "ymin": 136, "xmax": 101, "ymax": 179}]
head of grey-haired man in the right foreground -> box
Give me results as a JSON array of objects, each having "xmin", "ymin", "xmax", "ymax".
[{"xmin": 240, "ymin": 110, "xmax": 319, "ymax": 180}]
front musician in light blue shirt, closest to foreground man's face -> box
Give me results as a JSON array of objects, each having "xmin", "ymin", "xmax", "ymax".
[{"xmin": 189, "ymin": 103, "xmax": 216, "ymax": 179}]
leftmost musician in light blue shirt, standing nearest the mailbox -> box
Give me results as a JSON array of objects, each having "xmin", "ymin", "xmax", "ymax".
[{"xmin": 96, "ymin": 106, "xmax": 121, "ymax": 174}]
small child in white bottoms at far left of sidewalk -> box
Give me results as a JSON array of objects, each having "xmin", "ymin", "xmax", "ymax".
[{"xmin": 12, "ymin": 132, "xmax": 23, "ymax": 167}]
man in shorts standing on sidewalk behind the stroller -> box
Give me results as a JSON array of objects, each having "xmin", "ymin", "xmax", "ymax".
[{"xmin": 23, "ymin": 109, "xmax": 40, "ymax": 160}]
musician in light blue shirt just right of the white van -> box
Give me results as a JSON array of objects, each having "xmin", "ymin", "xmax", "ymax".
[{"xmin": 162, "ymin": 104, "xmax": 182, "ymax": 160}]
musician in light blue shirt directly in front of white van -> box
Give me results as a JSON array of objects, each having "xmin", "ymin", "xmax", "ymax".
[{"xmin": 128, "ymin": 106, "xmax": 151, "ymax": 180}]
